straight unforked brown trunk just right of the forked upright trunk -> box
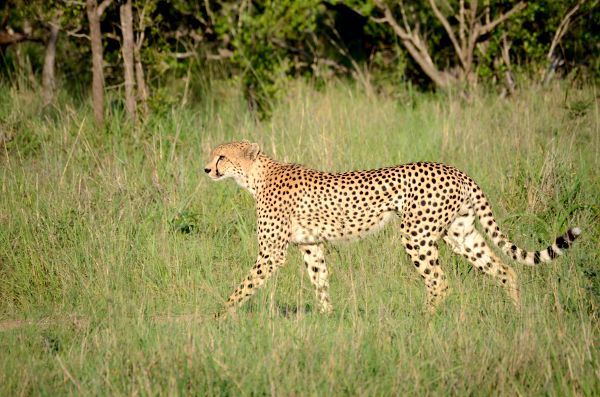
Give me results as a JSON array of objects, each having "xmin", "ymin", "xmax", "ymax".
[{"xmin": 120, "ymin": 0, "xmax": 135, "ymax": 120}]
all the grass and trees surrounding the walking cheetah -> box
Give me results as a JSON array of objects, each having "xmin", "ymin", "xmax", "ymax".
[{"xmin": 0, "ymin": 0, "xmax": 600, "ymax": 396}]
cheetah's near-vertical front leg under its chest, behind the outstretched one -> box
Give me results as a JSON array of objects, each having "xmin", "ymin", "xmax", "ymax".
[{"xmin": 300, "ymin": 244, "xmax": 333, "ymax": 313}]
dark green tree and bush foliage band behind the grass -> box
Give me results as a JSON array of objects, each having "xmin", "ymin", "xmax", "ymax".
[{"xmin": 0, "ymin": 0, "xmax": 600, "ymax": 115}]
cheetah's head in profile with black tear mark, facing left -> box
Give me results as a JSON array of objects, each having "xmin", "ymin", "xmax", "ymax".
[{"xmin": 204, "ymin": 140, "xmax": 260, "ymax": 187}]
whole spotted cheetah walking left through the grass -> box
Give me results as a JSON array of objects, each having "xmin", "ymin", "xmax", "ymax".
[{"xmin": 204, "ymin": 140, "xmax": 581, "ymax": 316}]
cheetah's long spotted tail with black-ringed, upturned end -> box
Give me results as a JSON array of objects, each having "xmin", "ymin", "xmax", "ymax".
[{"xmin": 471, "ymin": 187, "xmax": 581, "ymax": 266}]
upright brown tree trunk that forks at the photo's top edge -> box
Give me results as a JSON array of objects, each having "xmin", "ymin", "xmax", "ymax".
[{"xmin": 86, "ymin": 0, "xmax": 111, "ymax": 124}]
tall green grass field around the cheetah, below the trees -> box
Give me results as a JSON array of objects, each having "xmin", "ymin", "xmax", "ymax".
[{"xmin": 0, "ymin": 79, "xmax": 600, "ymax": 396}]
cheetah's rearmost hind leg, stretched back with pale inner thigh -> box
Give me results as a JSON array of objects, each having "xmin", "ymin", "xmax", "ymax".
[{"xmin": 444, "ymin": 214, "xmax": 521, "ymax": 310}]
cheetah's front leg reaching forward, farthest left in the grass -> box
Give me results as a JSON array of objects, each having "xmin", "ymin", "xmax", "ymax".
[{"xmin": 216, "ymin": 241, "xmax": 287, "ymax": 317}]
